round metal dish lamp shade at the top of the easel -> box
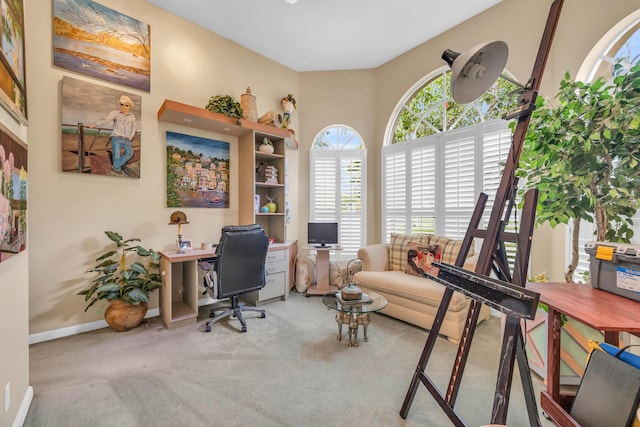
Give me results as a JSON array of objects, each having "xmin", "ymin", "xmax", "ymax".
[{"xmin": 443, "ymin": 41, "xmax": 509, "ymax": 104}]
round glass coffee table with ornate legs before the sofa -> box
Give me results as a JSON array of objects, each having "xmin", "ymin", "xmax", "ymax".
[{"xmin": 322, "ymin": 291, "xmax": 387, "ymax": 347}]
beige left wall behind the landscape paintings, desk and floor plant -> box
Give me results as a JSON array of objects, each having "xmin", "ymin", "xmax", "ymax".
[{"xmin": 27, "ymin": 0, "xmax": 299, "ymax": 340}]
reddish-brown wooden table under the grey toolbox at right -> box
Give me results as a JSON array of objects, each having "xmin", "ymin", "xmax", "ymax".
[{"xmin": 526, "ymin": 283, "xmax": 640, "ymax": 427}]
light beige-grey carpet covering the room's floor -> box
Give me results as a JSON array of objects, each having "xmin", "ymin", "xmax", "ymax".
[{"xmin": 24, "ymin": 292, "xmax": 553, "ymax": 427}]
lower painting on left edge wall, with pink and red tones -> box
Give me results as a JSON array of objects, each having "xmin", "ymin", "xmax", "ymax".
[{"xmin": 0, "ymin": 130, "xmax": 27, "ymax": 262}]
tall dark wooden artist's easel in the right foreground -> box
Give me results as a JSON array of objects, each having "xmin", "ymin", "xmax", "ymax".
[{"xmin": 400, "ymin": 0, "xmax": 563, "ymax": 426}]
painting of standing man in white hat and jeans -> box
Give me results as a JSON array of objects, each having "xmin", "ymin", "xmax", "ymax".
[{"xmin": 61, "ymin": 76, "xmax": 142, "ymax": 178}]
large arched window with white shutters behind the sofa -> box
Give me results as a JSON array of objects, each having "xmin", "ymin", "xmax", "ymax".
[{"xmin": 382, "ymin": 67, "xmax": 517, "ymax": 241}]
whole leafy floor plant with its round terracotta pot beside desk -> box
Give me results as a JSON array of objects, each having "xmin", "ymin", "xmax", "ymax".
[{"xmin": 78, "ymin": 231, "xmax": 162, "ymax": 331}]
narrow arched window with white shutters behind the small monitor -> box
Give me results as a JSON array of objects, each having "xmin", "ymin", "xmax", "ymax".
[{"xmin": 309, "ymin": 125, "xmax": 367, "ymax": 258}]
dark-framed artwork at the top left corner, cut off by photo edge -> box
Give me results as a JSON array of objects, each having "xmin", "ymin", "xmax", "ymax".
[{"xmin": 0, "ymin": 0, "xmax": 27, "ymax": 125}]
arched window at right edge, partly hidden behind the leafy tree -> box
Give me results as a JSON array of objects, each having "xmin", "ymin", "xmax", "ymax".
[{"xmin": 566, "ymin": 15, "xmax": 640, "ymax": 282}]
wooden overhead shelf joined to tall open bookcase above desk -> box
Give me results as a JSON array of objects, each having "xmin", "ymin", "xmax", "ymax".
[{"xmin": 158, "ymin": 99, "xmax": 295, "ymax": 243}]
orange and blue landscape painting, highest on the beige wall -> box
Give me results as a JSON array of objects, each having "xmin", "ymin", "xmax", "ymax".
[{"xmin": 53, "ymin": 0, "xmax": 151, "ymax": 92}]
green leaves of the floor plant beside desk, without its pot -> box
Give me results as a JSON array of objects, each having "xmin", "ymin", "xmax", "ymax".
[{"xmin": 78, "ymin": 231, "xmax": 162, "ymax": 311}]
